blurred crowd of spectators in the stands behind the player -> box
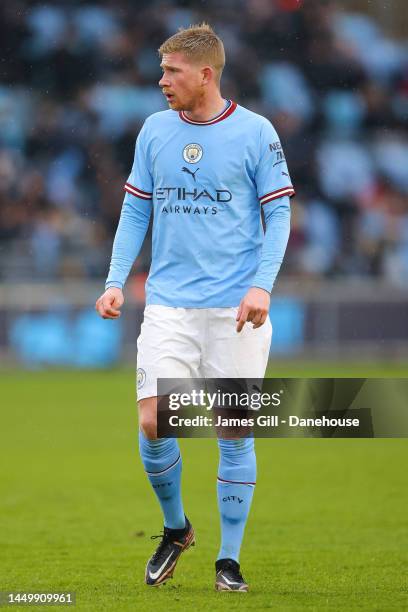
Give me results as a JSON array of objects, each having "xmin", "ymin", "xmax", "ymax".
[{"xmin": 0, "ymin": 0, "xmax": 408, "ymax": 286}]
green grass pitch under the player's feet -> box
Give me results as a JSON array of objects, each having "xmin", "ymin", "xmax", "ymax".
[{"xmin": 0, "ymin": 363, "xmax": 408, "ymax": 612}]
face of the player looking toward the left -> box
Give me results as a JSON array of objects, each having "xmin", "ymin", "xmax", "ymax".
[{"xmin": 159, "ymin": 53, "xmax": 204, "ymax": 111}]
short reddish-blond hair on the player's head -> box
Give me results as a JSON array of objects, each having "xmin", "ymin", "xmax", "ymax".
[{"xmin": 158, "ymin": 22, "xmax": 225, "ymax": 83}]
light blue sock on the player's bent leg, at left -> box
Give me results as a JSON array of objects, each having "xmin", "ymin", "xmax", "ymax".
[{"xmin": 139, "ymin": 431, "xmax": 186, "ymax": 529}]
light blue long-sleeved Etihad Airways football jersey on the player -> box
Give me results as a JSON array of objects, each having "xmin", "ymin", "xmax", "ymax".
[{"xmin": 106, "ymin": 102, "xmax": 294, "ymax": 308}]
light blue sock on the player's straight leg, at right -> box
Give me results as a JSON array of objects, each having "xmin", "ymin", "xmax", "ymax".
[{"xmin": 217, "ymin": 438, "xmax": 256, "ymax": 563}]
